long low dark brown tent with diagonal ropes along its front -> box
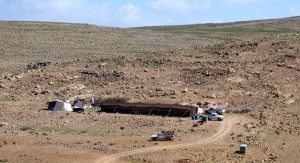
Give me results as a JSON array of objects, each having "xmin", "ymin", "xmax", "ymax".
[{"xmin": 101, "ymin": 102, "xmax": 197, "ymax": 117}]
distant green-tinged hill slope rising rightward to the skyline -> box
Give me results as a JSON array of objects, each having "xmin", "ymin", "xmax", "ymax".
[{"xmin": 138, "ymin": 17, "xmax": 300, "ymax": 40}]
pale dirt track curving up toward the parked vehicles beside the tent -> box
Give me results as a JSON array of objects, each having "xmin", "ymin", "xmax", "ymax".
[{"xmin": 96, "ymin": 116, "xmax": 238, "ymax": 163}]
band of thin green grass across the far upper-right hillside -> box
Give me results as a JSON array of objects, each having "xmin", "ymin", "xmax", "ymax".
[{"xmin": 141, "ymin": 22, "xmax": 300, "ymax": 41}]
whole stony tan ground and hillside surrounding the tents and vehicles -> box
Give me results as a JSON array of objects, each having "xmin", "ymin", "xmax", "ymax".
[{"xmin": 0, "ymin": 17, "xmax": 300, "ymax": 162}]
